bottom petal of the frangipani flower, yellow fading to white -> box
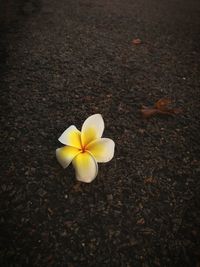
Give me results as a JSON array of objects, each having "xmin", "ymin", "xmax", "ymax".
[{"xmin": 72, "ymin": 152, "xmax": 98, "ymax": 183}]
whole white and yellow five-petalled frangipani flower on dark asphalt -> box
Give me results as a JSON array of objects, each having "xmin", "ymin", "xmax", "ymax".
[{"xmin": 56, "ymin": 114, "xmax": 115, "ymax": 183}]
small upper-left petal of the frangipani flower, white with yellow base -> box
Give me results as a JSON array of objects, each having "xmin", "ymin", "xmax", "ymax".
[{"xmin": 58, "ymin": 125, "xmax": 81, "ymax": 148}]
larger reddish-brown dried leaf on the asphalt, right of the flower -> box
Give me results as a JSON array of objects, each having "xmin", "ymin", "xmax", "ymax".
[{"xmin": 141, "ymin": 98, "xmax": 182, "ymax": 118}]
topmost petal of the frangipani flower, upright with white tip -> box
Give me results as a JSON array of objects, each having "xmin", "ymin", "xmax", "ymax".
[{"xmin": 81, "ymin": 114, "xmax": 104, "ymax": 146}]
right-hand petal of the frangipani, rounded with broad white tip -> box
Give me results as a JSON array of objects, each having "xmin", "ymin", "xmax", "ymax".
[{"xmin": 86, "ymin": 138, "xmax": 115, "ymax": 162}]
